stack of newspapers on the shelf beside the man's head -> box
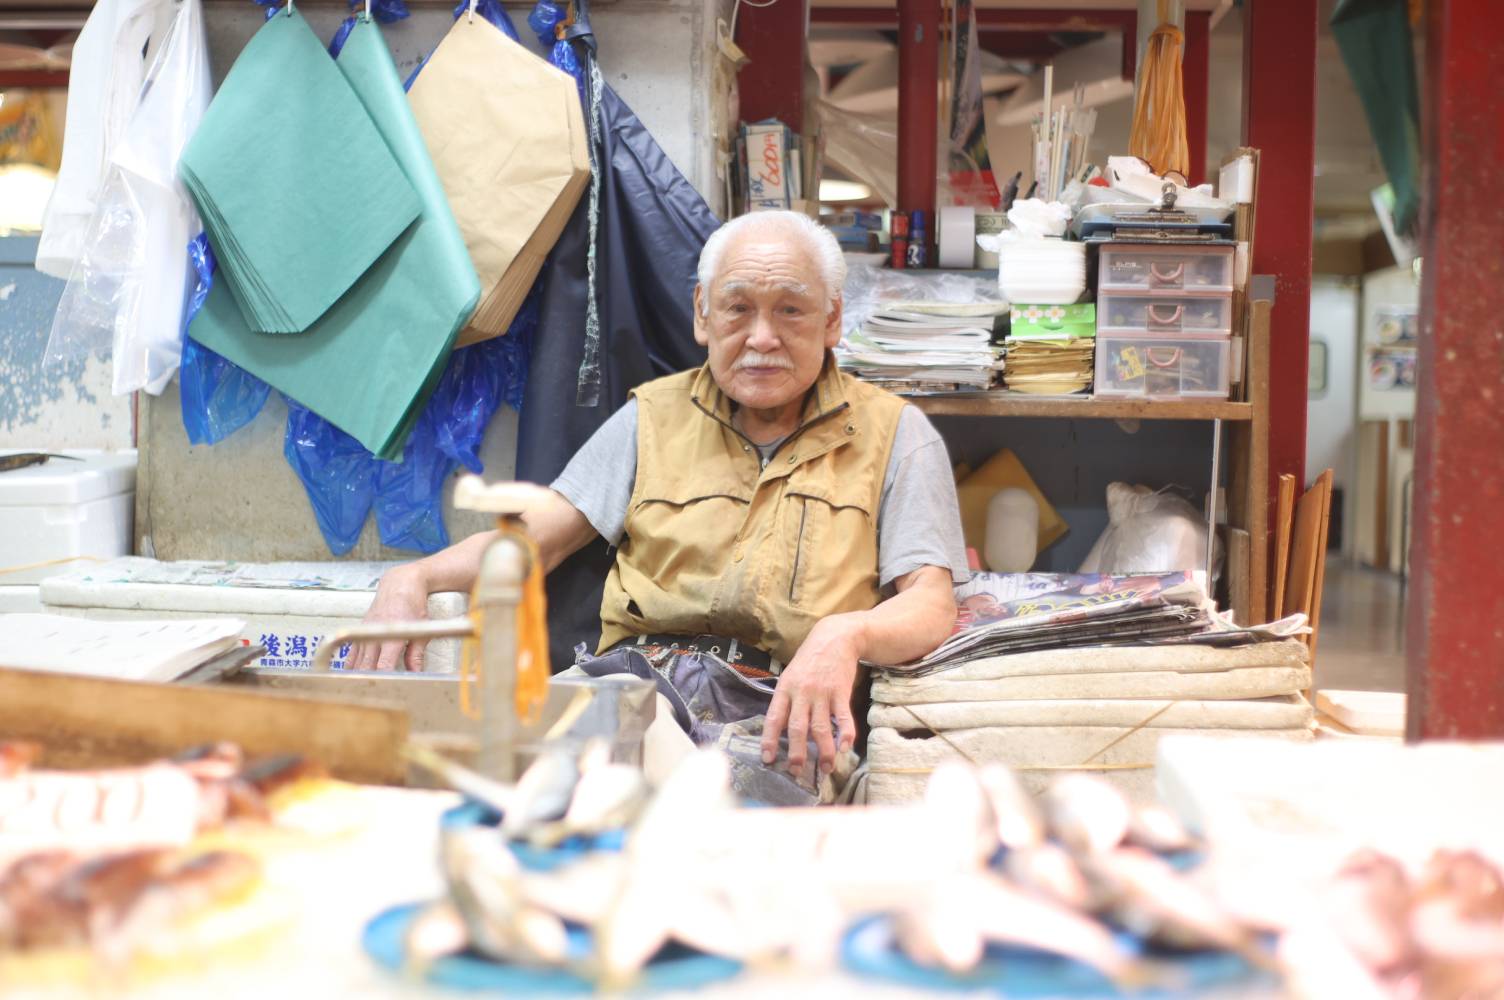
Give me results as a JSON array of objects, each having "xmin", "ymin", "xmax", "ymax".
[{"xmin": 836, "ymin": 302, "xmax": 1006, "ymax": 392}]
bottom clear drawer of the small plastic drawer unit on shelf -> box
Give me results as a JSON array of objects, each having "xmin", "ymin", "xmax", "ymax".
[{"xmin": 1096, "ymin": 335, "xmax": 1230, "ymax": 400}]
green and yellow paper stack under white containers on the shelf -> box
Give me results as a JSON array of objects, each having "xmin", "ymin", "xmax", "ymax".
[{"xmin": 1006, "ymin": 302, "xmax": 1096, "ymax": 395}]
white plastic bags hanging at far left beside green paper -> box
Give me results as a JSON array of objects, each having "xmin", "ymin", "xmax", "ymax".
[{"xmin": 47, "ymin": 0, "xmax": 212, "ymax": 395}]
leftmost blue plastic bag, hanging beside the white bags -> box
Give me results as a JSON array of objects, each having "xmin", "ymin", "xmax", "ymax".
[{"xmin": 177, "ymin": 233, "xmax": 271, "ymax": 445}]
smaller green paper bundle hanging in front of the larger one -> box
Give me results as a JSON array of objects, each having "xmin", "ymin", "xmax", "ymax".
[{"xmin": 179, "ymin": 12, "xmax": 420, "ymax": 333}]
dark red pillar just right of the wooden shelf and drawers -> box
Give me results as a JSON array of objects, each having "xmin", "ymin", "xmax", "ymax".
[{"xmin": 1242, "ymin": 0, "xmax": 1321, "ymax": 496}]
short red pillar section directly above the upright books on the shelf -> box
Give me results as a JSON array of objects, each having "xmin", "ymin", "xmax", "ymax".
[{"xmin": 735, "ymin": 0, "xmax": 809, "ymax": 132}]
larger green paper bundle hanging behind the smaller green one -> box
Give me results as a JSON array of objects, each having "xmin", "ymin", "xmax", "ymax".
[{"xmin": 188, "ymin": 15, "xmax": 480, "ymax": 460}]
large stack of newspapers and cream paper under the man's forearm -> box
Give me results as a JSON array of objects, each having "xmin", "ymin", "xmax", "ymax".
[{"xmin": 865, "ymin": 573, "xmax": 1313, "ymax": 803}]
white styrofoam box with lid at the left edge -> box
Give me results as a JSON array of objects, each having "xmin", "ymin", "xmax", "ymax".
[{"xmin": 0, "ymin": 448, "xmax": 135, "ymax": 583}]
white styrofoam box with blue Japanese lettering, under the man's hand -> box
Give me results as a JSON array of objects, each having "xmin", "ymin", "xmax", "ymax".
[{"xmin": 41, "ymin": 556, "xmax": 468, "ymax": 674}]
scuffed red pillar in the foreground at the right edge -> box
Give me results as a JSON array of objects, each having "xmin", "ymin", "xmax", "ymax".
[{"xmin": 1406, "ymin": 0, "xmax": 1504, "ymax": 740}]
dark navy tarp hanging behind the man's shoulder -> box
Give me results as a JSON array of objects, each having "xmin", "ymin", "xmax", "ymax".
[{"xmin": 517, "ymin": 5, "xmax": 720, "ymax": 669}]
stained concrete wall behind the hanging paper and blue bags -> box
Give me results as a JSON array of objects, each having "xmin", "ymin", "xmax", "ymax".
[{"xmin": 137, "ymin": 0, "xmax": 729, "ymax": 561}]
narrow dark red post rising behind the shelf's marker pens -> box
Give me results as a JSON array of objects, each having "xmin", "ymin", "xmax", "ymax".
[{"xmin": 898, "ymin": 0, "xmax": 940, "ymax": 225}]
